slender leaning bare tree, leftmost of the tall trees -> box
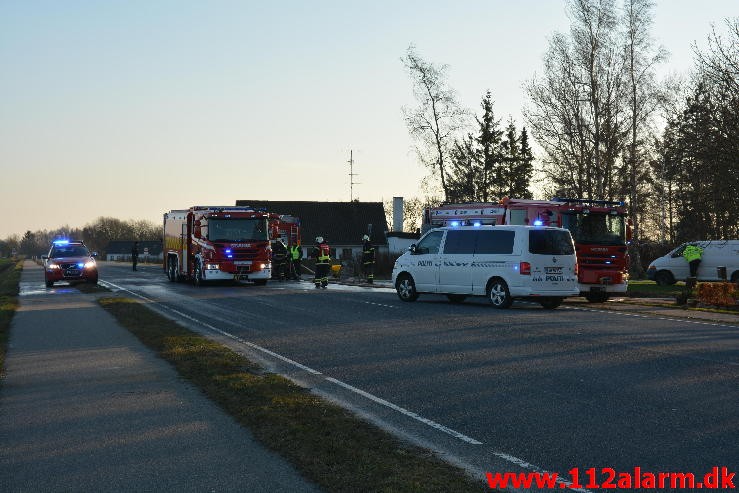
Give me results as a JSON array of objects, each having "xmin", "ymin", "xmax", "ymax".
[{"xmin": 402, "ymin": 45, "xmax": 466, "ymax": 200}]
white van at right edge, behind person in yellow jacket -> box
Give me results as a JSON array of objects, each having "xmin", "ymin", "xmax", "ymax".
[{"xmin": 647, "ymin": 240, "xmax": 739, "ymax": 286}]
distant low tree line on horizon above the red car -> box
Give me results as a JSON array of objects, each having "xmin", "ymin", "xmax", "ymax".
[{"xmin": 0, "ymin": 217, "xmax": 162, "ymax": 257}]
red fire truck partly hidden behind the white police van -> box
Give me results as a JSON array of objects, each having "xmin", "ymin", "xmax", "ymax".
[{"xmin": 423, "ymin": 197, "xmax": 631, "ymax": 303}]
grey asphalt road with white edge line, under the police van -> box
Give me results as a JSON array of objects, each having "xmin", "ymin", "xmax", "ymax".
[{"xmin": 101, "ymin": 263, "xmax": 739, "ymax": 484}]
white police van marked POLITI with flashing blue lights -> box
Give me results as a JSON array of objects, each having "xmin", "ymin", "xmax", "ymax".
[{"xmin": 393, "ymin": 226, "xmax": 580, "ymax": 309}]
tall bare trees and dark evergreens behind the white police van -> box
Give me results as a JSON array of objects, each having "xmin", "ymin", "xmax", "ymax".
[{"xmin": 402, "ymin": 0, "xmax": 739, "ymax": 264}]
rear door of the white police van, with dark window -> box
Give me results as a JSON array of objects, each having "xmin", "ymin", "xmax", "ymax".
[{"xmin": 529, "ymin": 228, "xmax": 577, "ymax": 294}]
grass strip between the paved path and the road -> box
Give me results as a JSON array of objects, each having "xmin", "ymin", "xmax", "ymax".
[{"xmin": 100, "ymin": 297, "xmax": 491, "ymax": 493}]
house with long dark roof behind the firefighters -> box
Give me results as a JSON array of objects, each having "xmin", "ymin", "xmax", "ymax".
[{"xmin": 236, "ymin": 200, "xmax": 388, "ymax": 260}]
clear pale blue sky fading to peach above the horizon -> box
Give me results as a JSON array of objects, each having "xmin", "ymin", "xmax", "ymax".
[{"xmin": 0, "ymin": 0, "xmax": 739, "ymax": 238}]
